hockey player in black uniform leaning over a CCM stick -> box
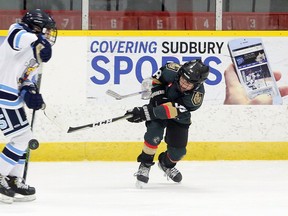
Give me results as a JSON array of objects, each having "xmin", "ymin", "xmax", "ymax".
[{"xmin": 126, "ymin": 60, "xmax": 209, "ymax": 188}]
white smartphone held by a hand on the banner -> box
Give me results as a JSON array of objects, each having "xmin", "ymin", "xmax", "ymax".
[{"xmin": 228, "ymin": 38, "xmax": 282, "ymax": 104}]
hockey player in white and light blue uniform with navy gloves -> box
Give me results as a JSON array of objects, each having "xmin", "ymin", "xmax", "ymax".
[{"xmin": 0, "ymin": 9, "xmax": 57, "ymax": 203}]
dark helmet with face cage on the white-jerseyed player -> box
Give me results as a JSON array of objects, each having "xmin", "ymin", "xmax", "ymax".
[{"xmin": 22, "ymin": 9, "xmax": 57, "ymax": 45}]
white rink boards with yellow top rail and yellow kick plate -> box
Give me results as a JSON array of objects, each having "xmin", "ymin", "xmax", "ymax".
[{"xmin": 0, "ymin": 31, "xmax": 288, "ymax": 161}]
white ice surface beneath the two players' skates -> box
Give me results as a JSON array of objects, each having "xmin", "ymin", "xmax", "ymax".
[{"xmin": 0, "ymin": 161, "xmax": 288, "ymax": 216}]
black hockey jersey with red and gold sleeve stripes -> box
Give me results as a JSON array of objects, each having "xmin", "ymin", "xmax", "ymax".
[{"xmin": 150, "ymin": 63, "xmax": 205, "ymax": 124}]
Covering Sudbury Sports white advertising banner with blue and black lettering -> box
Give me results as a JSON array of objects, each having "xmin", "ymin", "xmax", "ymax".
[{"xmin": 87, "ymin": 37, "xmax": 288, "ymax": 104}]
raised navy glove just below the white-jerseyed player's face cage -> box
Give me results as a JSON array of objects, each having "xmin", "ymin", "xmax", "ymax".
[{"xmin": 33, "ymin": 34, "xmax": 52, "ymax": 63}]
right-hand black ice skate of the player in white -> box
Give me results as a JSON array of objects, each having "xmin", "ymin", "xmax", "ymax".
[{"xmin": 8, "ymin": 176, "xmax": 36, "ymax": 202}]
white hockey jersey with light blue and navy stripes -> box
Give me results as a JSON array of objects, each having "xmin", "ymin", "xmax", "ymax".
[{"xmin": 0, "ymin": 23, "xmax": 39, "ymax": 109}]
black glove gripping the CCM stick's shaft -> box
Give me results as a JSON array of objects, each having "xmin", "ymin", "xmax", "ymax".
[{"xmin": 125, "ymin": 104, "xmax": 155, "ymax": 123}]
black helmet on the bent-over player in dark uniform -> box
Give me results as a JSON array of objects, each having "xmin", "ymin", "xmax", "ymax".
[{"xmin": 179, "ymin": 59, "xmax": 209, "ymax": 85}]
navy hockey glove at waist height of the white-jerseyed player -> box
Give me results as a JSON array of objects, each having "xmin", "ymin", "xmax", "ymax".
[{"xmin": 21, "ymin": 86, "xmax": 45, "ymax": 110}]
